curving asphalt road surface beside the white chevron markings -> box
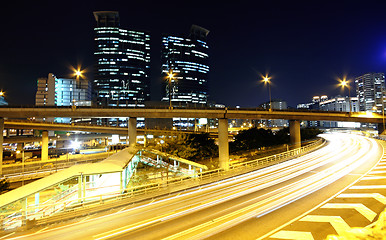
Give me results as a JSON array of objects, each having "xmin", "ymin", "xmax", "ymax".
[{"xmin": 9, "ymin": 134, "xmax": 383, "ymax": 240}]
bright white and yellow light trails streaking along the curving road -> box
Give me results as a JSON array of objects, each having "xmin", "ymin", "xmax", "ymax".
[{"xmin": 6, "ymin": 134, "xmax": 379, "ymax": 239}]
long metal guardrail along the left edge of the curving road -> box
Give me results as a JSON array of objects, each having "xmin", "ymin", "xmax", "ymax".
[{"xmin": 0, "ymin": 139, "xmax": 325, "ymax": 228}]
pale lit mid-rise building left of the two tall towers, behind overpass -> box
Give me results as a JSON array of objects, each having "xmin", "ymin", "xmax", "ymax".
[{"xmin": 35, "ymin": 73, "xmax": 92, "ymax": 122}]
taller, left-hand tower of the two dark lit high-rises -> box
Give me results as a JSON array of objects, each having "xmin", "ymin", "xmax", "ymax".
[{"xmin": 94, "ymin": 11, "xmax": 150, "ymax": 107}]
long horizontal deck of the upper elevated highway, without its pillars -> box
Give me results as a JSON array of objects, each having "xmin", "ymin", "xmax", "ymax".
[{"xmin": 0, "ymin": 107, "xmax": 383, "ymax": 123}]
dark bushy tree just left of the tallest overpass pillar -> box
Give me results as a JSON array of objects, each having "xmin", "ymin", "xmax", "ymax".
[{"xmin": 157, "ymin": 133, "xmax": 218, "ymax": 161}]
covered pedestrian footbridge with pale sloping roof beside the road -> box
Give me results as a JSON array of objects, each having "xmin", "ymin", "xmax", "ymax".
[{"xmin": 0, "ymin": 147, "xmax": 207, "ymax": 229}]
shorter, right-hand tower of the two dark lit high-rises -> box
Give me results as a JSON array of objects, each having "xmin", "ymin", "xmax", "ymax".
[{"xmin": 161, "ymin": 25, "xmax": 209, "ymax": 106}]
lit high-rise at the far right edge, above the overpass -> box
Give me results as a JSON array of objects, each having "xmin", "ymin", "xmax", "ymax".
[{"xmin": 355, "ymin": 73, "xmax": 385, "ymax": 113}]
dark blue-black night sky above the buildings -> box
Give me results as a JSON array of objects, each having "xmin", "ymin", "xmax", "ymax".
[{"xmin": 0, "ymin": 0, "xmax": 386, "ymax": 107}]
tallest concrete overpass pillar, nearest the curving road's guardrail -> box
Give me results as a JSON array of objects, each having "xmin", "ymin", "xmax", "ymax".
[{"xmin": 218, "ymin": 118, "xmax": 229, "ymax": 171}]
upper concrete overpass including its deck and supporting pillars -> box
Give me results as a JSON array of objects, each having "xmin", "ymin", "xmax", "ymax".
[{"xmin": 0, "ymin": 107, "xmax": 384, "ymax": 174}]
